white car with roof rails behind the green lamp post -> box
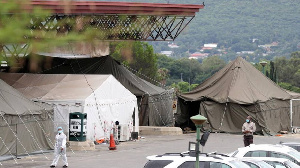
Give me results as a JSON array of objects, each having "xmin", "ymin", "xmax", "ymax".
[{"xmin": 144, "ymin": 153, "xmax": 250, "ymax": 168}]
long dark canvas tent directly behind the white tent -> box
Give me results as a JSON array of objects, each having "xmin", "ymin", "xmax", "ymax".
[{"xmin": 7, "ymin": 54, "xmax": 174, "ymax": 126}]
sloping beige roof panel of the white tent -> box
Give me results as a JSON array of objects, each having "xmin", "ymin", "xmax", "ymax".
[{"xmin": 0, "ymin": 73, "xmax": 116, "ymax": 101}]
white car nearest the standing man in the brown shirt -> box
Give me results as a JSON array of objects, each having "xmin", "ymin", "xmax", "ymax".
[{"xmin": 229, "ymin": 144, "xmax": 300, "ymax": 165}]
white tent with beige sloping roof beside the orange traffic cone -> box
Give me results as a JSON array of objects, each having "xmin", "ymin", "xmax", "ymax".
[{"xmin": 0, "ymin": 73, "xmax": 139, "ymax": 140}]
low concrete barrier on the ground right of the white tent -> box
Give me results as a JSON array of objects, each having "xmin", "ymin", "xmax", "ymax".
[{"xmin": 139, "ymin": 126, "xmax": 182, "ymax": 136}]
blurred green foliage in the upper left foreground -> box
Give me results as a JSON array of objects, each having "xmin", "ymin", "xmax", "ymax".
[{"xmin": 0, "ymin": 0, "xmax": 115, "ymax": 66}]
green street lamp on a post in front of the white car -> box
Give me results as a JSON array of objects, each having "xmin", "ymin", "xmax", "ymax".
[{"xmin": 191, "ymin": 114, "xmax": 207, "ymax": 168}]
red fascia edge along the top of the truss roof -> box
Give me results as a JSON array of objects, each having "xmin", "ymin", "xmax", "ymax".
[{"xmin": 31, "ymin": 0, "xmax": 203, "ymax": 16}]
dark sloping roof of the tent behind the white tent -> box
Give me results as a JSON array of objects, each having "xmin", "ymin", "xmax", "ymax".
[{"xmin": 17, "ymin": 55, "xmax": 165, "ymax": 96}]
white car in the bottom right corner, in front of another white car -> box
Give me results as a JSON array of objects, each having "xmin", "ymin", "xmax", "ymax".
[{"xmin": 246, "ymin": 157, "xmax": 300, "ymax": 168}]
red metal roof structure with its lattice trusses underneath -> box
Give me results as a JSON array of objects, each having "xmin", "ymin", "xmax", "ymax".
[{"xmin": 25, "ymin": 0, "xmax": 204, "ymax": 41}]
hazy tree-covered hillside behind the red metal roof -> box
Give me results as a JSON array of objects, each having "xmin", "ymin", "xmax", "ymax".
[{"xmin": 93, "ymin": 0, "xmax": 300, "ymax": 62}]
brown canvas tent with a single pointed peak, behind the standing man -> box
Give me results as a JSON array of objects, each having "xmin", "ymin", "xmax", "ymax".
[{"xmin": 176, "ymin": 57, "xmax": 300, "ymax": 134}]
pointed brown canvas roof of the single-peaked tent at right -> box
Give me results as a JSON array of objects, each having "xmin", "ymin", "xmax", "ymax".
[{"xmin": 180, "ymin": 57, "xmax": 291, "ymax": 104}]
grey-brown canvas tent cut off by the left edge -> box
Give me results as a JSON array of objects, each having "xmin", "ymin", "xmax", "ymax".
[{"xmin": 0, "ymin": 79, "xmax": 54, "ymax": 155}]
